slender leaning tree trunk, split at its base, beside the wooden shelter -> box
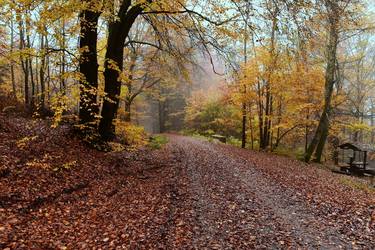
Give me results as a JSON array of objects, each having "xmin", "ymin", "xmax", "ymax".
[{"xmin": 305, "ymin": 1, "xmax": 339, "ymax": 162}]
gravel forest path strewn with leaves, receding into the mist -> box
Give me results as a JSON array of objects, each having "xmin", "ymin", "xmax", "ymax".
[{"xmin": 167, "ymin": 135, "xmax": 364, "ymax": 249}]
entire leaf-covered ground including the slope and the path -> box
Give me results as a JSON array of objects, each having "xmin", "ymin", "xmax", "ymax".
[{"xmin": 0, "ymin": 115, "xmax": 375, "ymax": 249}]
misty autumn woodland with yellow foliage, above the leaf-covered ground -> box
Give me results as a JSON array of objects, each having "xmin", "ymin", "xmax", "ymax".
[{"xmin": 0, "ymin": 0, "xmax": 375, "ymax": 161}]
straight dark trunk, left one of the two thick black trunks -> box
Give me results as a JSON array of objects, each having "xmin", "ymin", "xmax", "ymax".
[{"xmin": 79, "ymin": 9, "xmax": 100, "ymax": 128}]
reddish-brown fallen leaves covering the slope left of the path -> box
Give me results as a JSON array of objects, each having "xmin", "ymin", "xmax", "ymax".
[{"xmin": 0, "ymin": 115, "xmax": 177, "ymax": 249}]
